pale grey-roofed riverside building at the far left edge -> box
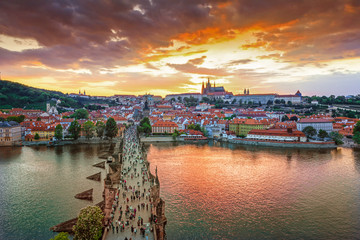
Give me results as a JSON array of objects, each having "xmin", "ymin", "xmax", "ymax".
[{"xmin": 0, "ymin": 121, "xmax": 21, "ymax": 146}]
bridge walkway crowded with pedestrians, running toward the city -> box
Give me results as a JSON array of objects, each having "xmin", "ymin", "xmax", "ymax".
[{"xmin": 108, "ymin": 126, "xmax": 155, "ymax": 240}]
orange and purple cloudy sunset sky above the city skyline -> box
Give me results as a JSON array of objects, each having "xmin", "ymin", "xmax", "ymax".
[{"xmin": 0, "ymin": 0, "xmax": 360, "ymax": 96}]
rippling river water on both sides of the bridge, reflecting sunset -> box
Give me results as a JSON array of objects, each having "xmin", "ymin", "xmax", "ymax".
[{"xmin": 0, "ymin": 143, "xmax": 360, "ymax": 240}]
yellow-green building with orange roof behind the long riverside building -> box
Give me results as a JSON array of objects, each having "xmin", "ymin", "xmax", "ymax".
[{"xmin": 229, "ymin": 119, "xmax": 270, "ymax": 136}]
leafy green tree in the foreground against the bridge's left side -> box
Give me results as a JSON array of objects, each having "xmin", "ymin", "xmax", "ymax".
[{"xmin": 73, "ymin": 206, "xmax": 104, "ymax": 240}]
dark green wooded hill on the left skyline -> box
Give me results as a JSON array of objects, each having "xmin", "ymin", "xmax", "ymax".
[{"xmin": 0, "ymin": 80, "xmax": 83, "ymax": 110}]
